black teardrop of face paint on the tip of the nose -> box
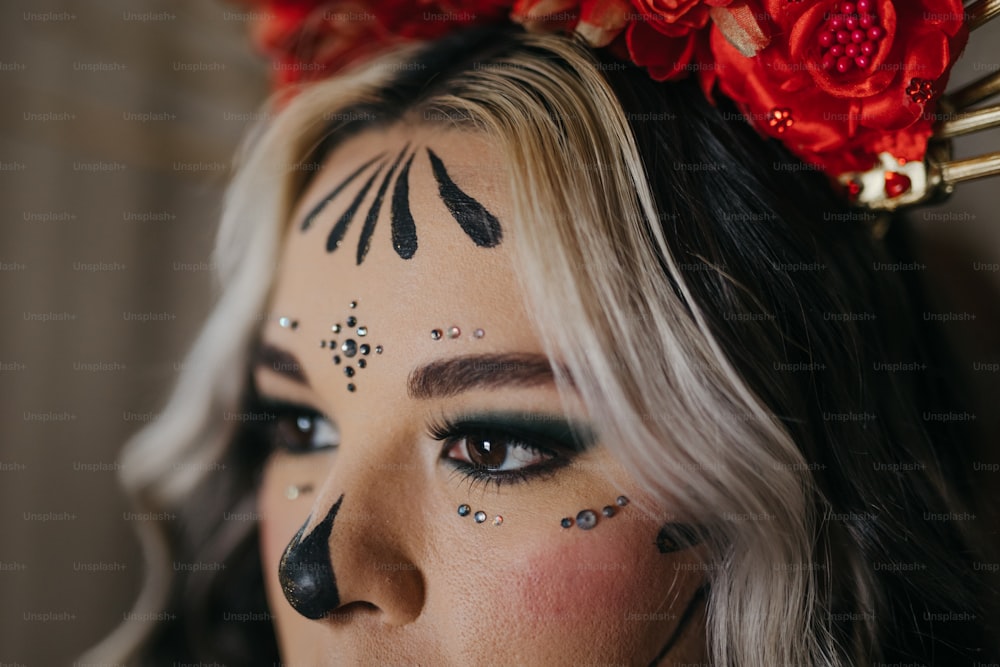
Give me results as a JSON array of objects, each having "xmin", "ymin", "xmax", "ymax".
[{"xmin": 278, "ymin": 494, "xmax": 344, "ymax": 620}]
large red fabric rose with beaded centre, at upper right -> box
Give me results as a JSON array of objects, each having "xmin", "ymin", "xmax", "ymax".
[{"xmin": 711, "ymin": 0, "xmax": 968, "ymax": 175}]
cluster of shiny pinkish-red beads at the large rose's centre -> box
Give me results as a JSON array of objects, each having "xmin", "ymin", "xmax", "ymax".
[{"xmin": 817, "ymin": 0, "xmax": 885, "ymax": 74}]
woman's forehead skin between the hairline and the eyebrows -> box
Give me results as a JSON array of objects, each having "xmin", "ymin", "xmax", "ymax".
[{"xmin": 265, "ymin": 128, "xmax": 538, "ymax": 390}]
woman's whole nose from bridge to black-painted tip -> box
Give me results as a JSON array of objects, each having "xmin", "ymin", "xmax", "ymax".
[{"xmin": 281, "ymin": 420, "xmax": 424, "ymax": 625}]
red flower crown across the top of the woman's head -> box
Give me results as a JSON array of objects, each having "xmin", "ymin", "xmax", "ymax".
[{"xmin": 241, "ymin": 0, "xmax": 997, "ymax": 208}]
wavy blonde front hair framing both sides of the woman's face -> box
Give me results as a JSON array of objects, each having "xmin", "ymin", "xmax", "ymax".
[{"xmin": 82, "ymin": 26, "xmax": 988, "ymax": 667}]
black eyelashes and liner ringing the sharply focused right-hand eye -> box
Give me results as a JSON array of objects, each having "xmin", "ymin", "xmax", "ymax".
[{"xmin": 427, "ymin": 417, "xmax": 575, "ymax": 487}]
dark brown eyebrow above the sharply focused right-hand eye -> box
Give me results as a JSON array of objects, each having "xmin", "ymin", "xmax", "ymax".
[{"xmin": 407, "ymin": 353, "xmax": 569, "ymax": 399}]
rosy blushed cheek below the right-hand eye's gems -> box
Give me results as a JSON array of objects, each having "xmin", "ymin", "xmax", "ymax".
[{"xmin": 470, "ymin": 525, "xmax": 701, "ymax": 661}]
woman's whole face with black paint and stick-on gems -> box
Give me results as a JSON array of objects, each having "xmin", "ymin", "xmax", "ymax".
[{"xmin": 254, "ymin": 122, "xmax": 704, "ymax": 666}]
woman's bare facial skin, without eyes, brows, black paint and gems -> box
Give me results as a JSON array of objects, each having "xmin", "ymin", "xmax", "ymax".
[{"xmin": 254, "ymin": 127, "xmax": 705, "ymax": 666}]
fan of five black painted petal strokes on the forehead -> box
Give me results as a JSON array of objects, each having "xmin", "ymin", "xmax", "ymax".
[{"xmin": 300, "ymin": 144, "xmax": 503, "ymax": 265}]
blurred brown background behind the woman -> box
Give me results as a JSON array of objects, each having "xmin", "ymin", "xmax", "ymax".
[{"xmin": 0, "ymin": 0, "xmax": 1000, "ymax": 666}]
